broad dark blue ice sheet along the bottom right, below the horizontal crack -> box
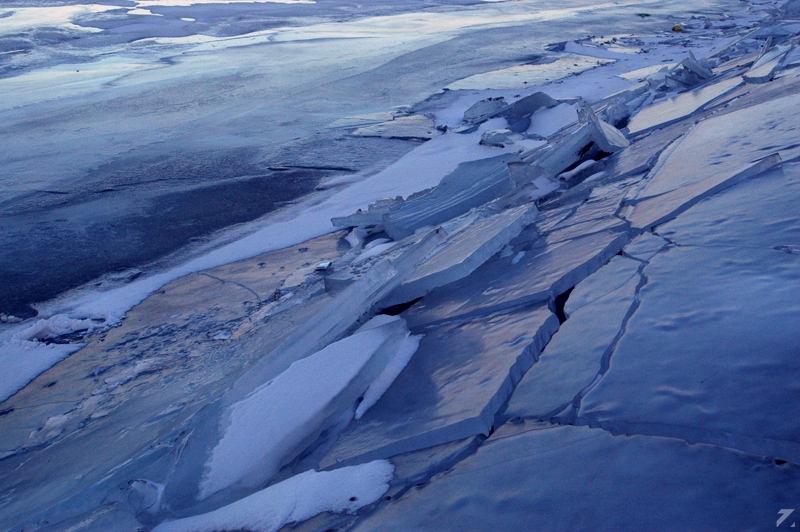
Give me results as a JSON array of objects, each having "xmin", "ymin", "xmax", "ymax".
[{"xmin": 355, "ymin": 423, "xmax": 800, "ymax": 532}]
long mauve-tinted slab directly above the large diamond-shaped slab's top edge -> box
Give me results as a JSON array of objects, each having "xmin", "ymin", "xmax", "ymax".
[{"xmin": 404, "ymin": 231, "xmax": 628, "ymax": 330}]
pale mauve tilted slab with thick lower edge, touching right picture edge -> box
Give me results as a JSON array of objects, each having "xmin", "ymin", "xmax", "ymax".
[{"xmin": 622, "ymin": 90, "xmax": 800, "ymax": 229}]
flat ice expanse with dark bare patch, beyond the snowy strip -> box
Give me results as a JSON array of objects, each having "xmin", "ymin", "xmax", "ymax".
[{"xmin": 0, "ymin": 0, "xmax": 738, "ymax": 317}]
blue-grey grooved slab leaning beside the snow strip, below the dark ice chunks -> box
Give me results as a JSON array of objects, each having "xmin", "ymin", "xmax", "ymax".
[{"xmin": 383, "ymin": 154, "xmax": 519, "ymax": 240}]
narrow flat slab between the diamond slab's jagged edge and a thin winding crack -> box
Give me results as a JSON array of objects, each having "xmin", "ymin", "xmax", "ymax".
[{"xmin": 504, "ymin": 257, "xmax": 641, "ymax": 419}]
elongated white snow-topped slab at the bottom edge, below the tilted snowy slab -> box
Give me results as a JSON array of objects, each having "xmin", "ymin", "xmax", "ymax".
[{"xmin": 153, "ymin": 460, "xmax": 394, "ymax": 532}]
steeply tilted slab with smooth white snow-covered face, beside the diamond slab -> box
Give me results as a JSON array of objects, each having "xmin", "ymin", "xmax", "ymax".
[{"xmin": 199, "ymin": 316, "xmax": 409, "ymax": 499}]
